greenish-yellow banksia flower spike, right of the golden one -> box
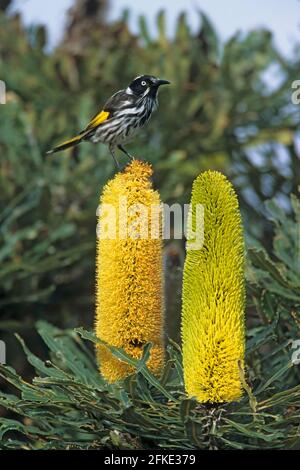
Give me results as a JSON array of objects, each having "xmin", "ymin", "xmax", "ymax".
[{"xmin": 182, "ymin": 171, "xmax": 245, "ymax": 403}]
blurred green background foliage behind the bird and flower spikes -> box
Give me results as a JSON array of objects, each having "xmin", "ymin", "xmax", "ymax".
[{"xmin": 0, "ymin": 0, "xmax": 300, "ymax": 400}]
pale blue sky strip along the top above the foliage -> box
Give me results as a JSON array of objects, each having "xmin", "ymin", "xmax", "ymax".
[{"xmin": 16, "ymin": 0, "xmax": 300, "ymax": 54}]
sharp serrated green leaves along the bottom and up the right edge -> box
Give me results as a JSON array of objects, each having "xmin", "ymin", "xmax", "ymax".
[{"xmin": 0, "ymin": 197, "xmax": 300, "ymax": 449}]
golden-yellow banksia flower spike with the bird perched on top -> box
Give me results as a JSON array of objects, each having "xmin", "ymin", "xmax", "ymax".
[{"xmin": 96, "ymin": 160, "xmax": 164, "ymax": 382}]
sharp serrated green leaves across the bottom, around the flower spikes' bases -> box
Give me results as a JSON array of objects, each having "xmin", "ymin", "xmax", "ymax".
[{"xmin": 0, "ymin": 321, "xmax": 300, "ymax": 449}]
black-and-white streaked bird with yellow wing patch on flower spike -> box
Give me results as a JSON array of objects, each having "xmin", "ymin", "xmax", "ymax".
[{"xmin": 47, "ymin": 75, "xmax": 170, "ymax": 170}]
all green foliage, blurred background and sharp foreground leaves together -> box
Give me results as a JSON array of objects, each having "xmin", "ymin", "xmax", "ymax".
[{"xmin": 0, "ymin": 0, "xmax": 300, "ymax": 448}]
